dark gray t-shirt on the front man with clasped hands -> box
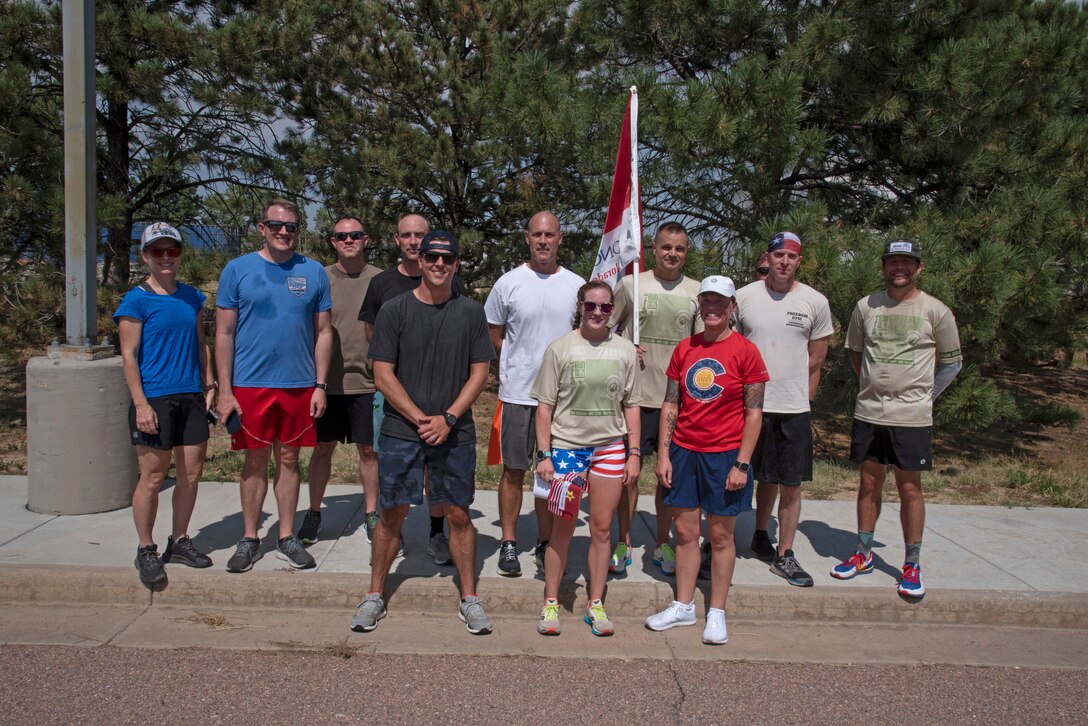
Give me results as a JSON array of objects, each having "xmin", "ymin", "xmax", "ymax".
[{"xmin": 369, "ymin": 292, "xmax": 495, "ymax": 446}]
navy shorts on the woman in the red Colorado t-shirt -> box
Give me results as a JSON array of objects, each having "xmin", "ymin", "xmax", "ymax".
[{"xmin": 664, "ymin": 443, "xmax": 754, "ymax": 517}]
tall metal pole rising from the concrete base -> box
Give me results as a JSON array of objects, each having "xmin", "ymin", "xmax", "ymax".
[{"xmin": 62, "ymin": 0, "xmax": 98, "ymax": 346}]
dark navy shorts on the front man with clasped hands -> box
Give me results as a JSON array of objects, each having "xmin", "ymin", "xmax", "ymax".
[{"xmin": 378, "ymin": 434, "xmax": 475, "ymax": 509}]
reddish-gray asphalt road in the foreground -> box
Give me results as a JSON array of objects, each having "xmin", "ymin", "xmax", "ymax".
[{"xmin": 0, "ymin": 645, "xmax": 1088, "ymax": 725}]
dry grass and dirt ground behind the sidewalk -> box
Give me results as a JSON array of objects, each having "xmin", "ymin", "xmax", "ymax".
[{"xmin": 0, "ymin": 365, "xmax": 1088, "ymax": 507}]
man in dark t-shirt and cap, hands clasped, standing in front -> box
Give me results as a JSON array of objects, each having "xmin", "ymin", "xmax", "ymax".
[{"xmin": 351, "ymin": 231, "xmax": 495, "ymax": 635}]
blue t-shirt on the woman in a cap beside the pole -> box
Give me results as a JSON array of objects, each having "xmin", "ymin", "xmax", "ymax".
[{"xmin": 113, "ymin": 282, "xmax": 207, "ymax": 398}]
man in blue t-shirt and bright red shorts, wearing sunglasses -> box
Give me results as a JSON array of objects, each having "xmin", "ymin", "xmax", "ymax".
[{"xmin": 215, "ymin": 199, "xmax": 333, "ymax": 573}]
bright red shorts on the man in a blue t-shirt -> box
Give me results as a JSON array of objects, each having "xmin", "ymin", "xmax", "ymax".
[{"xmin": 231, "ymin": 387, "xmax": 318, "ymax": 452}]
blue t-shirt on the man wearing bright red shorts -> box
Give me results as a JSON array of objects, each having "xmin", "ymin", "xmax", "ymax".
[{"xmin": 215, "ymin": 253, "xmax": 333, "ymax": 389}]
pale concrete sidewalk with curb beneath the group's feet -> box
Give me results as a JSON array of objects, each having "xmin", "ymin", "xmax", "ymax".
[{"xmin": 6, "ymin": 468, "xmax": 1088, "ymax": 628}]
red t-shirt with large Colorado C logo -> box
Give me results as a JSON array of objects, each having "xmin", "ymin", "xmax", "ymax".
[{"xmin": 665, "ymin": 332, "xmax": 770, "ymax": 452}]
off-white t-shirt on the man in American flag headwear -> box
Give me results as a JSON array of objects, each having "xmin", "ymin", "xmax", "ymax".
[{"xmin": 737, "ymin": 280, "xmax": 834, "ymax": 414}]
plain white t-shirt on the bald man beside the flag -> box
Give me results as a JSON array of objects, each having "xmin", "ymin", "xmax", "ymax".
[{"xmin": 483, "ymin": 264, "xmax": 585, "ymax": 406}]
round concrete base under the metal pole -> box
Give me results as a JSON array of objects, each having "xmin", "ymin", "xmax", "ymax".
[{"xmin": 26, "ymin": 357, "xmax": 139, "ymax": 515}]
